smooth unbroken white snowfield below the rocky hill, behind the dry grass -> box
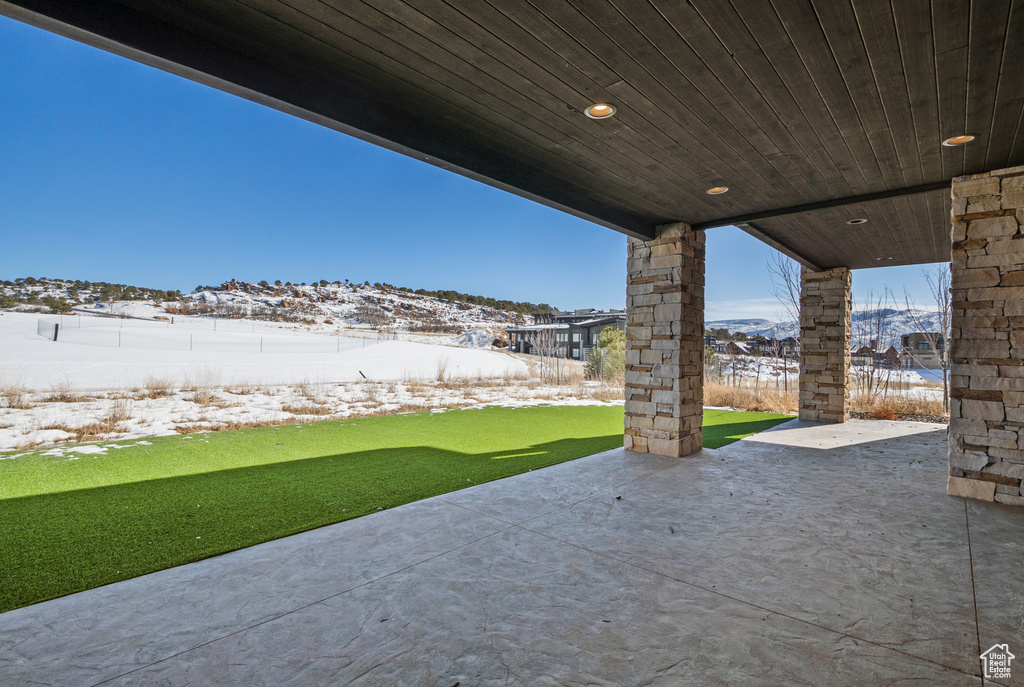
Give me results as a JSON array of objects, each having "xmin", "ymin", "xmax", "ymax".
[{"xmin": 0, "ymin": 312, "xmax": 526, "ymax": 391}]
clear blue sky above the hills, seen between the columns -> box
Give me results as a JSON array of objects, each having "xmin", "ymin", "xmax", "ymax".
[{"xmin": 0, "ymin": 17, "xmax": 942, "ymax": 320}]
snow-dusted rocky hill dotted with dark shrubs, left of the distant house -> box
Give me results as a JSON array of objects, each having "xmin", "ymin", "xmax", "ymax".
[{"xmin": 0, "ymin": 278, "xmax": 521, "ymax": 334}]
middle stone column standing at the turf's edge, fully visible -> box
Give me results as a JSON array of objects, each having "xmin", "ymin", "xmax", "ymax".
[{"xmin": 625, "ymin": 223, "xmax": 705, "ymax": 457}]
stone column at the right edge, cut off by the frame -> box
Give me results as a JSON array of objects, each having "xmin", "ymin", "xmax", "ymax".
[{"xmin": 947, "ymin": 167, "xmax": 1024, "ymax": 506}]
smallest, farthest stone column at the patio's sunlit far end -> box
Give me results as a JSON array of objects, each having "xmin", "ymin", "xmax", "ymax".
[{"xmin": 800, "ymin": 267, "xmax": 853, "ymax": 422}]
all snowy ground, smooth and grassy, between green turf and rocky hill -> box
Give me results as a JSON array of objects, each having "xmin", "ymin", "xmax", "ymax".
[{"xmin": 0, "ymin": 312, "xmax": 622, "ymax": 450}]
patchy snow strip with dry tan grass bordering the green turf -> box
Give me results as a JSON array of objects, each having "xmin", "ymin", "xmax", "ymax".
[{"xmin": 0, "ymin": 372, "xmax": 622, "ymax": 460}]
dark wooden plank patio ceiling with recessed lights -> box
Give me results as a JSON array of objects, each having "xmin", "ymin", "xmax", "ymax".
[{"xmin": 0, "ymin": 0, "xmax": 1024, "ymax": 267}]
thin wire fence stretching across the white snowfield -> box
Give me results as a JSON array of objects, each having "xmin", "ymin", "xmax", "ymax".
[{"xmin": 36, "ymin": 315, "xmax": 395, "ymax": 353}]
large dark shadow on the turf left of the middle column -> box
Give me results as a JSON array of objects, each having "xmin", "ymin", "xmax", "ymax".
[{"xmin": 0, "ymin": 434, "xmax": 622, "ymax": 612}]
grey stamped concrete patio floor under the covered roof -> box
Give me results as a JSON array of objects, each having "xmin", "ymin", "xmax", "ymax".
[{"xmin": 0, "ymin": 421, "xmax": 1024, "ymax": 687}]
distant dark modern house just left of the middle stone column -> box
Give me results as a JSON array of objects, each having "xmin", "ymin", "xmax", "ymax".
[{"xmin": 505, "ymin": 308, "xmax": 626, "ymax": 360}]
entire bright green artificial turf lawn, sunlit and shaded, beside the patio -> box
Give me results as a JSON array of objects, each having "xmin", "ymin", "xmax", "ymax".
[{"xmin": 0, "ymin": 405, "xmax": 788, "ymax": 611}]
